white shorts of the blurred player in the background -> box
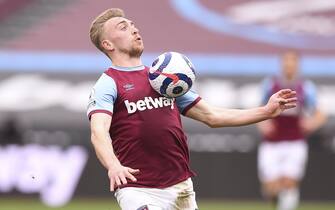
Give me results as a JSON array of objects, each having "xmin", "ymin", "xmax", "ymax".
[{"xmin": 258, "ymin": 140, "xmax": 308, "ymax": 182}]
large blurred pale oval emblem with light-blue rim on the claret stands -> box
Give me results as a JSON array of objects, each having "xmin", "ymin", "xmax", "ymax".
[{"xmin": 171, "ymin": 0, "xmax": 335, "ymax": 50}]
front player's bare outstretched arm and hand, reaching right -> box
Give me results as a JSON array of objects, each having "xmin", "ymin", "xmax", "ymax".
[{"xmin": 185, "ymin": 89, "xmax": 297, "ymax": 128}]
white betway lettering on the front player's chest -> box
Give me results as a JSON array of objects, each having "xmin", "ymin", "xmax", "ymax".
[{"xmin": 124, "ymin": 97, "xmax": 175, "ymax": 114}]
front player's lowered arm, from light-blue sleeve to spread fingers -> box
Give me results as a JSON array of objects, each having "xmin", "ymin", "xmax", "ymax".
[{"xmin": 87, "ymin": 74, "xmax": 139, "ymax": 191}]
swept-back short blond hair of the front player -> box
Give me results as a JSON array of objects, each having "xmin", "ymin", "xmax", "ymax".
[{"xmin": 90, "ymin": 8, "xmax": 125, "ymax": 54}]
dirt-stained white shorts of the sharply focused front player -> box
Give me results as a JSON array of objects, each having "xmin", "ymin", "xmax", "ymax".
[{"xmin": 115, "ymin": 178, "xmax": 198, "ymax": 210}]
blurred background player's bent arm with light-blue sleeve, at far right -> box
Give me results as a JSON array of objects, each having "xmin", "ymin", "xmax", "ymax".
[{"xmin": 301, "ymin": 81, "xmax": 327, "ymax": 134}]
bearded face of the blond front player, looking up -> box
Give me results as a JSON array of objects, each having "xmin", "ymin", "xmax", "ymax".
[{"xmin": 102, "ymin": 17, "xmax": 144, "ymax": 57}]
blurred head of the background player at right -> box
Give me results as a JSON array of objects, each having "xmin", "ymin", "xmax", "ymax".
[{"xmin": 283, "ymin": 52, "xmax": 299, "ymax": 79}]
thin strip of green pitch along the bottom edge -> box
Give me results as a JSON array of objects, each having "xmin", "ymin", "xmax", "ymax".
[{"xmin": 0, "ymin": 198, "xmax": 335, "ymax": 210}]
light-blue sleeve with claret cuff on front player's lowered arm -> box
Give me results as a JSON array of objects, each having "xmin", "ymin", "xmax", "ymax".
[{"xmin": 87, "ymin": 74, "xmax": 117, "ymax": 118}]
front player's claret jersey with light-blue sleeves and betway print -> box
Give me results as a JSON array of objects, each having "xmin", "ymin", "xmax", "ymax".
[{"xmin": 87, "ymin": 66, "xmax": 200, "ymax": 188}]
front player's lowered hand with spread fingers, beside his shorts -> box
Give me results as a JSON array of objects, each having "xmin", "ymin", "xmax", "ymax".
[{"xmin": 108, "ymin": 164, "xmax": 140, "ymax": 191}]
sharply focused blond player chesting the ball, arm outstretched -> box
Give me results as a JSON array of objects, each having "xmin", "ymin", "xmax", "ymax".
[{"xmin": 87, "ymin": 8, "xmax": 297, "ymax": 210}]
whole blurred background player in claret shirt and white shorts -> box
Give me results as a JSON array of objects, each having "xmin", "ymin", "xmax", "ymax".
[{"xmin": 258, "ymin": 51, "xmax": 326, "ymax": 210}]
